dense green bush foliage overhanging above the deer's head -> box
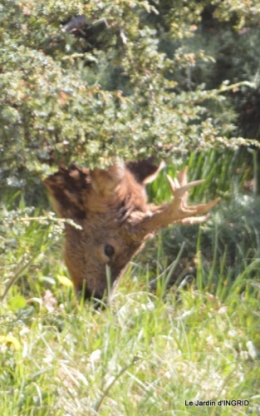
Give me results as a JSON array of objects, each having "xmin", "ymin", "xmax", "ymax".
[{"xmin": 0, "ymin": 0, "xmax": 260, "ymax": 191}]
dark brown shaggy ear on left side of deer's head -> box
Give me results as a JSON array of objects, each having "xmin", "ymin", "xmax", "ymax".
[{"xmin": 43, "ymin": 165, "xmax": 90, "ymax": 217}]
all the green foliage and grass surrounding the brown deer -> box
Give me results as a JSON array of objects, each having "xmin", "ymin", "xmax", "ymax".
[{"xmin": 0, "ymin": 0, "xmax": 260, "ymax": 416}]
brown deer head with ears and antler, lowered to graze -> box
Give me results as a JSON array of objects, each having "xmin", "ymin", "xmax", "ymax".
[{"xmin": 44, "ymin": 158, "xmax": 218, "ymax": 299}]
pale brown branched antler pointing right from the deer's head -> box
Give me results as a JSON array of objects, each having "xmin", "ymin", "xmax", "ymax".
[{"xmin": 133, "ymin": 167, "xmax": 220, "ymax": 235}]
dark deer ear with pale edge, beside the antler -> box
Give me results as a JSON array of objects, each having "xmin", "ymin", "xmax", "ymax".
[{"xmin": 126, "ymin": 157, "xmax": 165, "ymax": 185}]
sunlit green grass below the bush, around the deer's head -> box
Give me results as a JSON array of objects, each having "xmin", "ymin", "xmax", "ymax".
[{"xmin": 0, "ymin": 152, "xmax": 260, "ymax": 416}]
